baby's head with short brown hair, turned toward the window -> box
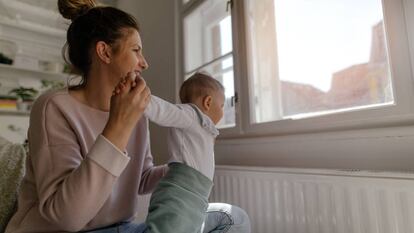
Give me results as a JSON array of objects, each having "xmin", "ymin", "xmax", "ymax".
[{"xmin": 180, "ymin": 72, "xmax": 225, "ymax": 124}]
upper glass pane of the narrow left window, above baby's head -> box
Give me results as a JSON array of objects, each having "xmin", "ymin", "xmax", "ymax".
[{"xmin": 184, "ymin": 0, "xmax": 233, "ymax": 73}]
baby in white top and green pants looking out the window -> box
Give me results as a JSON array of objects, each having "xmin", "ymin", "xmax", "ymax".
[{"xmin": 114, "ymin": 73, "xmax": 225, "ymax": 233}]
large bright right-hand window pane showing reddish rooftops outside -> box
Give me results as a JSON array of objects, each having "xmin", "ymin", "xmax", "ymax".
[{"xmin": 245, "ymin": 0, "xmax": 394, "ymax": 123}]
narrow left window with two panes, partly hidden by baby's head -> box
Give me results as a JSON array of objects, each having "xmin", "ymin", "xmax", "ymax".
[{"xmin": 183, "ymin": 0, "xmax": 235, "ymax": 128}]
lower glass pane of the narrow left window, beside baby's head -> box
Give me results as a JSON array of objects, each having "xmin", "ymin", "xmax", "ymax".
[{"xmin": 186, "ymin": 56, "xmax": 236, "ymax": 128}]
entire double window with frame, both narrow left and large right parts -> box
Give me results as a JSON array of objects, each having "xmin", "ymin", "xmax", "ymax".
[{"xmin": 182, "ymin": 0, "xmax": 414, "ymax": 135}]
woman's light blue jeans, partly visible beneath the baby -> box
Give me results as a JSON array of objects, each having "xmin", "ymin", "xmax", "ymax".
[{"xmin": 81, "ymin": 203, "xmax": 250, "ymax": 233}]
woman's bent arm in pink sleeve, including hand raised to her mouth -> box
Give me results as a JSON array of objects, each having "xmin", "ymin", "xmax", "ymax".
[{"xmin": 29, "ymin": 77, "xmax": 149, "ymax": 231}]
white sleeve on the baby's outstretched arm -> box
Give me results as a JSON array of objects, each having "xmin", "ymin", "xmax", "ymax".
[{"xmin": 144, "ymin": 95, "xmax": 196, "ymax": 128}]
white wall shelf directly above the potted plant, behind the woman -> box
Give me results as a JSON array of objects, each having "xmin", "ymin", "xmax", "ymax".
[{"xmin": 0, "ymin": 64, "xmax": 71, "ymax": 81}]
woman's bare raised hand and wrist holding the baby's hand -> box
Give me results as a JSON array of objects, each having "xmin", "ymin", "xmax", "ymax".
[{"xmin": 102, "ymin": 73, "xmax": 151, "ymax": 150}]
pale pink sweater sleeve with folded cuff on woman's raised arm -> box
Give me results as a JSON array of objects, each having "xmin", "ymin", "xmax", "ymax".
[{"xmin": 28, "ymin": 96, "xmax": 129, "ymax": 231}]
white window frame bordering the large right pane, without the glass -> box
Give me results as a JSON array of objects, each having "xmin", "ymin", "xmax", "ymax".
[{"xmin": 180, "ymin": 0, "xmax": 414, "ymax": 138}]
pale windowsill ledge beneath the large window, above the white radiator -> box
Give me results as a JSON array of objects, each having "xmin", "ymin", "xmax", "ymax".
[{"xmin": 215, "ymin": 124, "xmax": 414, "ymax": 170}]
